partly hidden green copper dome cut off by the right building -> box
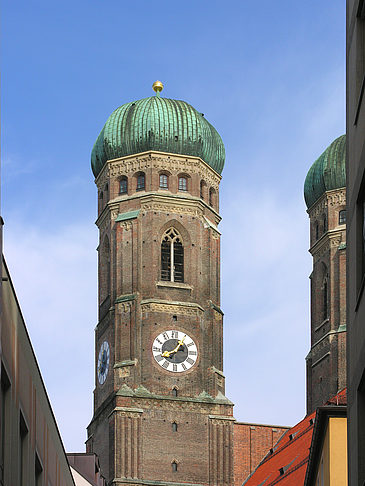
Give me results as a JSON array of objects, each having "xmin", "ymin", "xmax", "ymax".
[{"xmin": 304, "ymin": 135, "xmax": 346, "ymax": 208}]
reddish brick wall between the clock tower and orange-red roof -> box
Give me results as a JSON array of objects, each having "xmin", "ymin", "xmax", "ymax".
[{"xmin": 233, "ymin": 422, "xmax": 290, "ymax": 486}]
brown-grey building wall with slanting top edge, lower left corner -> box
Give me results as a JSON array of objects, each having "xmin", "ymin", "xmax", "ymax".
[{"xmin": 0, "ymin": 260, "xmax": 74, "ymax": 486}]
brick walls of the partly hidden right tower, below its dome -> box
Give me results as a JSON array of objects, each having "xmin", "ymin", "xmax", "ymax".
[{"xmin": 307, "ymin": 188, "xmax": 346, "ymax": 413}]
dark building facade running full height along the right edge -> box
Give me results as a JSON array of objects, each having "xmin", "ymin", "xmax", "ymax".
[{"xmin": 346, "ymin": 0, "xmax": 365, "ymax": 486}]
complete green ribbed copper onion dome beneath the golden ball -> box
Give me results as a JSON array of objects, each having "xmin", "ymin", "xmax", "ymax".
[{"xmin": 91, "ymin": 93, "xmax": 225, "ymax": 177}]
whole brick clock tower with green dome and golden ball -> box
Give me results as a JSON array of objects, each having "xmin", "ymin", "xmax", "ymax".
[{"xmin": 87, "ymin": 82, "xmax": 234, "ymax": 486}]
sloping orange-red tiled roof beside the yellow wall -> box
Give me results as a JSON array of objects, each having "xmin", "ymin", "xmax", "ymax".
[{"xmin": 243, "ymin": 388, "xmax": 346, "ymax": 486}]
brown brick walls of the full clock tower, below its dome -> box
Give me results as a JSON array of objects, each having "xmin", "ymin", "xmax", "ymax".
[{"xmin": 87, "ymin": 153, "xmax": 234, "ymax": 486}]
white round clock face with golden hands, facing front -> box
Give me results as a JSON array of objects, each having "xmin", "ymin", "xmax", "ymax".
[{"xmin": 152, "ymin": 330, "xmax": 198, "ymax": 373}]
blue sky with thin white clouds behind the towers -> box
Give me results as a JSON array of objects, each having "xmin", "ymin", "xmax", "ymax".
[{"xmin": 1, "ymin": 0, "xmax": 345, "ymax": 451}]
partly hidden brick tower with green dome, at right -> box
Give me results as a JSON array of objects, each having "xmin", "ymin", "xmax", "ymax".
[{"xmin": 304, "ymin": 135, "xmax": 346, "ymax": 413}]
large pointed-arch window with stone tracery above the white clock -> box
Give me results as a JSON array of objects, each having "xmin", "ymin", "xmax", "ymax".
[{"xmin": 161, "ymin": 228, "xmax": 184, "ymax": 282}]
